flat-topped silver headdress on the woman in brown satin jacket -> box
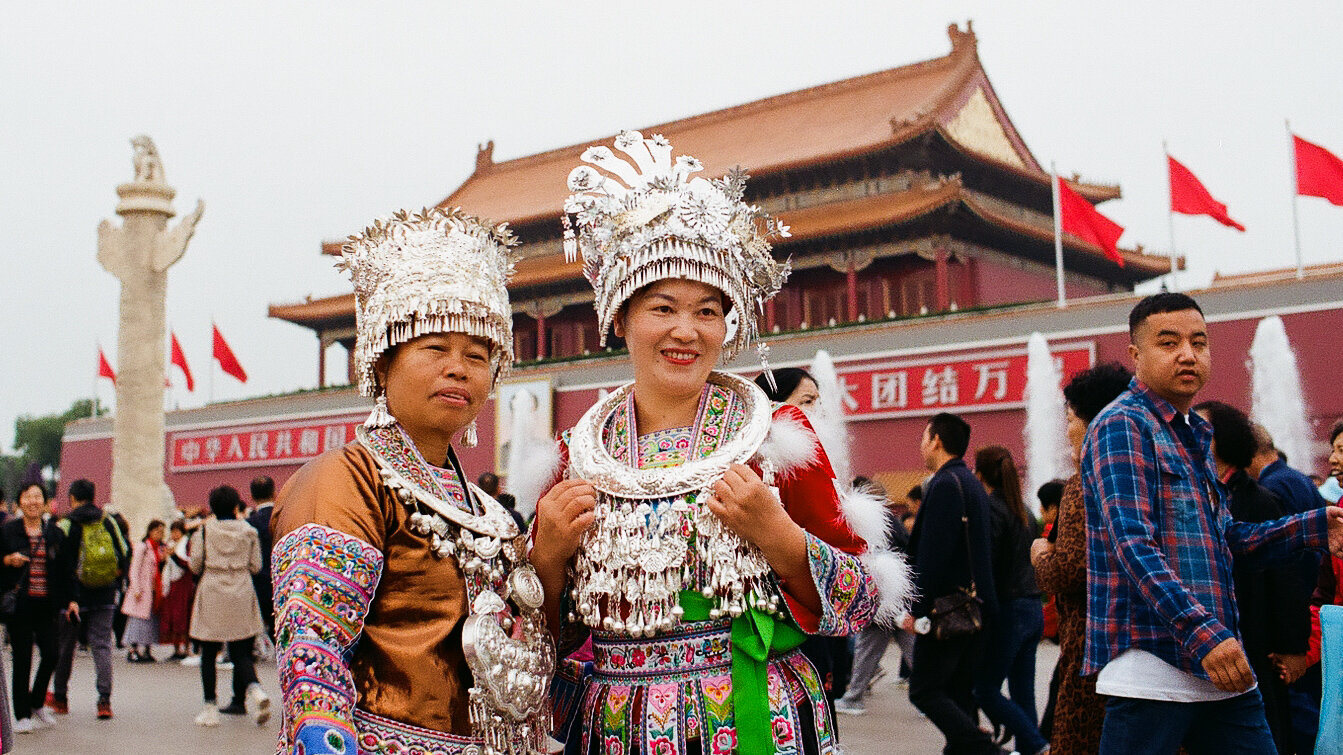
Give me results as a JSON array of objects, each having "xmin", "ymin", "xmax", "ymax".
[{"xmin": 336, "ymin": 207, "xmax": 517, "ymax": 427}]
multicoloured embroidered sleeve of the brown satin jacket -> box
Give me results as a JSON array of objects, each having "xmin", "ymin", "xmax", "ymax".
[{"xmin": 273, "ymin": 524, "xmax": 383, "ymax": 754}]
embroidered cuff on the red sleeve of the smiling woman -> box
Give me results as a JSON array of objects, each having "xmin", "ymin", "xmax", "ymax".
[{"xmin": 788, "ymin": 532, "xmax": 878, "ymax": 637}]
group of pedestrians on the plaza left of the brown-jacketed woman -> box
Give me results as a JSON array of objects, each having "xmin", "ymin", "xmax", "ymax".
[{"xmin": 0, "ymin": 477, "xmax": 275, "ymax": 735}]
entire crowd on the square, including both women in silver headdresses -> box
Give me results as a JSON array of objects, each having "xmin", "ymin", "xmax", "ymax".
[{"xmin": 0, "ymin": 132, "xmax": 1343, "ymax": 755}]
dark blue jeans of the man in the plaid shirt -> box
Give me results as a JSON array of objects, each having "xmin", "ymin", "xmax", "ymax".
[{"xmin": 1100, "ymin": 689, "xmax": 1277, "ymax": 755}]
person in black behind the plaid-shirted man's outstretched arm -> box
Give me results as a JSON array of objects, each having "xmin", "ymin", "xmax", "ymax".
[{"xmin": 1194, "ymin": 402, "xmax": 1313, "ymax": 754}]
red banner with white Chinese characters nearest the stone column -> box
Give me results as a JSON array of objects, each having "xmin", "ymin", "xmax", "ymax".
[{"xmin": 168, "ymin": 414, "xmax": 365, "ymax": 472}]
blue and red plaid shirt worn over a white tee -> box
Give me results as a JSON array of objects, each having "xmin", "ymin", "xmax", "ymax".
[{"xmin": 1081, "ymin": 378, "xmax": 1328, "ymax": 678}]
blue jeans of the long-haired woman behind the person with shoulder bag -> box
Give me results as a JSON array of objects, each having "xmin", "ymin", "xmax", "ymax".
[{"xmin": 975, "ymin": 598, "xmax": 1046, "ymax": 755}]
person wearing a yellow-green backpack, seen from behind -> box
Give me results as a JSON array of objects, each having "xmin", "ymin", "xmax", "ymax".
[{"xmin": 51, "ymin": 480, "xmax": 130, "ymax": 719}]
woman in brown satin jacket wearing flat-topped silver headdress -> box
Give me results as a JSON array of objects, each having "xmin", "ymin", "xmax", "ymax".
[{"xmin": 271, "ymin": 210, "xmax": 555, "ymax": 755}]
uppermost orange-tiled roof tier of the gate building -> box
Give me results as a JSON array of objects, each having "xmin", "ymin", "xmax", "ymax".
[{"xmin": 439, "ymin": 24, "xmax": 1119, "ymax": 226}]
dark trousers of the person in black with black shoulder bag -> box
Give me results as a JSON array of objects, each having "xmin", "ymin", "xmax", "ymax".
[{"xmin": 909, "ymin": 631, "xmax": 999, "ymax": 755}]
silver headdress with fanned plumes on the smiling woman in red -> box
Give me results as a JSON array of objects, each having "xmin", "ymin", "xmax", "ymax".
[{"xmin": 564, "ymin": 132, "xmax": 788, "ymax": 359}]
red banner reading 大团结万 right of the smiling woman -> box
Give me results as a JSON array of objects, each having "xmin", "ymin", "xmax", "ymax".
[{"xmin": 837, "ymin": 343, "xmax": 1096, "ymax": 419}]
